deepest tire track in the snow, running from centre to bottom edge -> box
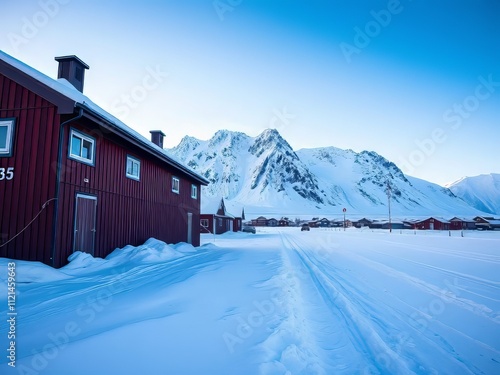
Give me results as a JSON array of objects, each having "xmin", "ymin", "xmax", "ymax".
[{"xmin": 281, "ymin": 233, "xmax": 414, "ymax": 374}]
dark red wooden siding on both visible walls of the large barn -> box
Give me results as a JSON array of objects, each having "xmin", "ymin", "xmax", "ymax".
[{"xmin": 0, "ymin": 67, "xmax": 201, "ymax": 267}]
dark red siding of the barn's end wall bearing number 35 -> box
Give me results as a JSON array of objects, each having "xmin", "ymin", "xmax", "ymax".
[{"xmin": 0, "ymin": 74, "xmax": 59, "ymax": 264}]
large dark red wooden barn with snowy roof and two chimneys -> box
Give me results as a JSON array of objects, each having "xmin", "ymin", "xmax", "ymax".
[{"xmin": 0, "ymin": 51, "xmax": 208, "ymax": 267}]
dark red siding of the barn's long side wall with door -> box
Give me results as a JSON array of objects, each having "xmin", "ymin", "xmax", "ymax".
[{"xmin": 56, "ymin": 120, "xmax": 200, "ymax": 265}]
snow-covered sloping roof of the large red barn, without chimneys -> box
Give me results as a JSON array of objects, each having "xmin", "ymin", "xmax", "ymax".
[{"xmin": 0, "ymin": 50, "xmax": 208, "ymax": 185}]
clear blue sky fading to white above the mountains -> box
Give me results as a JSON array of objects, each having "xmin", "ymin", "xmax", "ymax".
[{"xmin": 0, "ymin": 0, "xmax": 500, "ymax": 184}]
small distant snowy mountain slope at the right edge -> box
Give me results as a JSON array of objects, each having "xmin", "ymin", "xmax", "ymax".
[{"xmin": 447, "ymin": 173, "xmax": 500, "ymax": 215}]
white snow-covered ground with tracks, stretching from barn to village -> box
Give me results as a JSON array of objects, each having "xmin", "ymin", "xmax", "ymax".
[{"xmin": 0, "ymin": 228, "xmax": 500, "ymax": 375}]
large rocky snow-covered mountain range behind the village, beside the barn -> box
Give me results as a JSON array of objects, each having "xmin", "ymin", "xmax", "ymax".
[{"xmin": 168, "ymin": 129, "xmax": 480, "ymax": 217}]
